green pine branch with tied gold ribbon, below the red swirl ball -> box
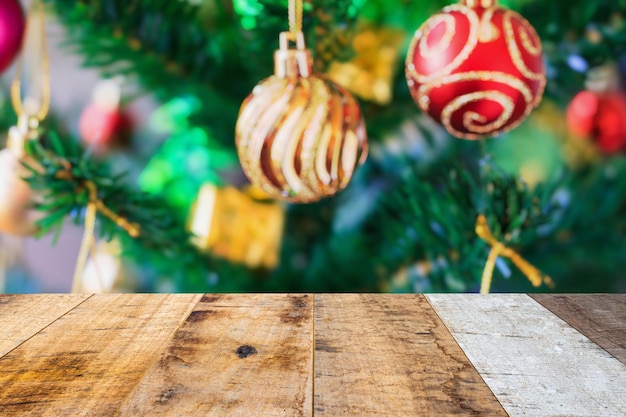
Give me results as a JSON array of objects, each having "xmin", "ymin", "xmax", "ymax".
[{"xmin": 364, "ymin": 155, "xmax": 626, "ymax": 291}]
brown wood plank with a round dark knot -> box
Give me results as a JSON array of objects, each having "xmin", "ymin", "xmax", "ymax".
[{"xmin": 120, "ymin": 294, "xmax": 313, "ymax": 417}]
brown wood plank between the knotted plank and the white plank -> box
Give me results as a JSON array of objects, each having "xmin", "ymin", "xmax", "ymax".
[{"xmin": 314, "ymin": 294, "xmax": 506, "ymax": 417}]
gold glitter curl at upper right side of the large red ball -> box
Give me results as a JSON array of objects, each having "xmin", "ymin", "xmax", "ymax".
[{"xmin": 502, "ymin": 11, "xmax": 545, "ymax": 81}]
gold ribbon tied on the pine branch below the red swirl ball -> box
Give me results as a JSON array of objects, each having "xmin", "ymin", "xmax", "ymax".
[{"xmin": 476, "ymin": 214, "xmax": 555, "ymax": 294}]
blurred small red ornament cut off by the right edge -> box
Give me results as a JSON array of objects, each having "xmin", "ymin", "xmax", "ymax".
[{"xmin": 566, "ymin": 91, "xmax": 626, "ymax": 154}]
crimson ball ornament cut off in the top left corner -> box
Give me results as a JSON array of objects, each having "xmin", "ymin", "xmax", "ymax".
[{"xmin": 0, "ymin": 0, "xmax": 25, "ymax": 72}]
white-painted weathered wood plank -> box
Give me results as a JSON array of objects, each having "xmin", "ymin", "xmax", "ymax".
[{"xmin": 427, "ymin": 294, "xmax": 626, "ymax": 417}]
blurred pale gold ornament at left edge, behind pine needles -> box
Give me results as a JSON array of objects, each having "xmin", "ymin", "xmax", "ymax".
[{"xmin": 0, "ymin": 118, "xmax": 43, "ymax": 236}]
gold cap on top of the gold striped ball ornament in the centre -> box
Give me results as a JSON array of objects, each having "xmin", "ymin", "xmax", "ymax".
[{"xmin": 274, "ymin": 32, "xmax": 313, "ymax": 78}]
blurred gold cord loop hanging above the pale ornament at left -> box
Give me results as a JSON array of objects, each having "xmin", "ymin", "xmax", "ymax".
[{"xmin": 11, "ymin": 0, "xmax": 50, "ymax": 120}]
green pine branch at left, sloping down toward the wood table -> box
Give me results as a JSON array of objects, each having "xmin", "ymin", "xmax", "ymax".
[{"xmin": 26, "ymin": 128, "xmax": 249, "ymax": 291}]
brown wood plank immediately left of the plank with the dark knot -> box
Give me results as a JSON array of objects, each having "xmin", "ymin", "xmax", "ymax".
[{"xmin": 0, "ymin": 294, "xmax": 200, "ymax": 417}]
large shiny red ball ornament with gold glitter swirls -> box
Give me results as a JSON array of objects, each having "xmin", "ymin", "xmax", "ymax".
[{"xmin": 406, "ymin": 0, "xmax": 546, "ymax": 139}]
